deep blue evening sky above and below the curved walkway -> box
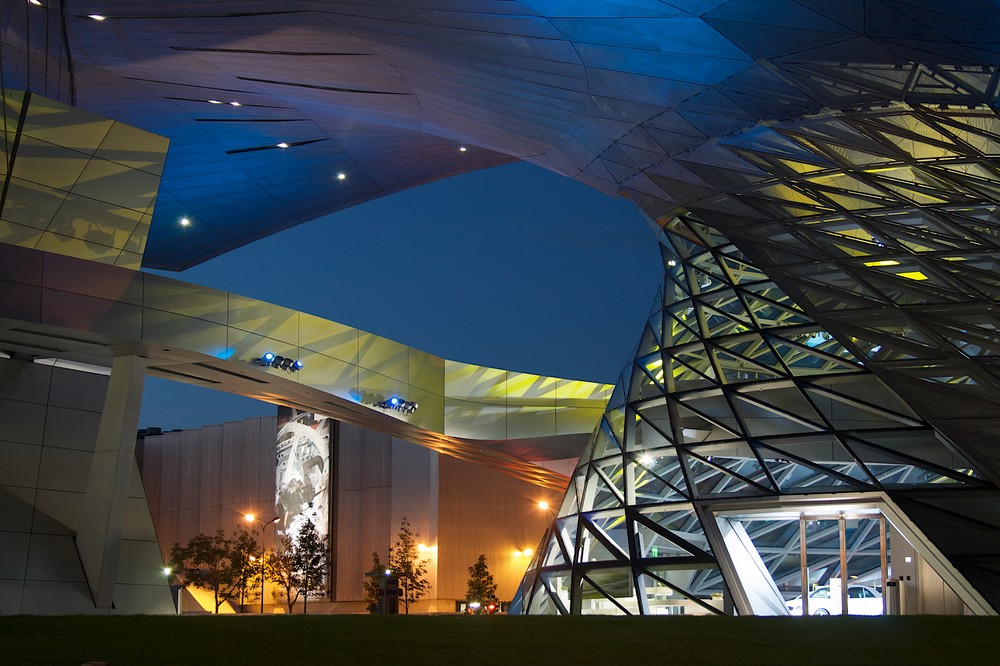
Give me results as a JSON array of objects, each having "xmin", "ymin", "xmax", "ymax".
[{"xmin": 140, "ymin": 163, "xmax": 662, "ymax": 429}]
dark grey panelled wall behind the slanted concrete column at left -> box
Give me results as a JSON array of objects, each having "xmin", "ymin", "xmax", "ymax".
[{"xmin": 0, "ymin": 359, "xmax": 172, "ymax": 615}]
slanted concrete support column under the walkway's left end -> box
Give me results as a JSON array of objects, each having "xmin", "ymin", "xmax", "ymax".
[{"xmin": 76, "ymin": 356, "xmax": 146, "ymax": 609}]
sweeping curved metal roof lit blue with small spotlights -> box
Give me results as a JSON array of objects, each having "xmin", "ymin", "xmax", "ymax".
[{"xmin": 7, "ymin": 0, "xmax": 1000, "ymax": 269}]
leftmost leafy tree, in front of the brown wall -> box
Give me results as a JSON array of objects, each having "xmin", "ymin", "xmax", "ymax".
[{"xmin": 170, "ymin": 530, "xmax": 245, "ymax": 613}]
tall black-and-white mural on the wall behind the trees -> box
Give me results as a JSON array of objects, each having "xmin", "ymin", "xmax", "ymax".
[{"xmin": 274, "ymin": 407, "xmax": 333, "ymax": 539}]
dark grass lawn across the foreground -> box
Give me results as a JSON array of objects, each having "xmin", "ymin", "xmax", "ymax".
[{"xmin": 0, "ymin": 615, "xmax": 1000, "ymax": 666}]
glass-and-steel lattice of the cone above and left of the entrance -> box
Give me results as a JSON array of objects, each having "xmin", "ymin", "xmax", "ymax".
[{"xmin": 523, "ymin": 211, "xmax": 991, "ymax": 613}]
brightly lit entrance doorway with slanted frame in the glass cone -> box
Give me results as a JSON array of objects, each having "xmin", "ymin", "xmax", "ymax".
[{"xmin": 713, "ymin": 498, "xmax": 988, "ymax": 616}]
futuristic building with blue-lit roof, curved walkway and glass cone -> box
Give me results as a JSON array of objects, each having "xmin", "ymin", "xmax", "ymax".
[{"xmin": 0, "ymin": 0, "xmax": 1000, "ymax": 614}]
